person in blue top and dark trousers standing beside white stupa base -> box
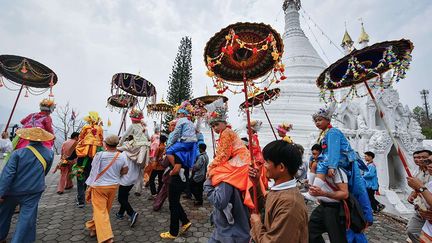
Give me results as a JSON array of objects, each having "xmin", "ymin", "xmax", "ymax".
[{"xmin": 363, "ymin": 151, "xmax": 385, "ymax": 213}]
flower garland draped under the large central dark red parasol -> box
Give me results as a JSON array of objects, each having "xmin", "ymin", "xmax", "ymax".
[{"xmin": 206, "ymin": 29, "xmax": 286, "ymax": 94}]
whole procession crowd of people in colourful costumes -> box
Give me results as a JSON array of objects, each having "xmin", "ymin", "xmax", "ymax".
[{"xmin": 0, "ymin": 100, "xmax": 432, "ymax": 243}]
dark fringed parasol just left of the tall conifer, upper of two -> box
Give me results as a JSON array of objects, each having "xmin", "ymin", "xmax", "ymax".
[{"xmin": 111, "ymin": 73, "xmax": 156, "ymax": 110}]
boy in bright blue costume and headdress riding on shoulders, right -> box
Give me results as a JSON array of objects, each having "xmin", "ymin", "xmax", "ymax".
[{"xmin": 312, "ymin": 106, "xmax": 373, "ymax": 242}]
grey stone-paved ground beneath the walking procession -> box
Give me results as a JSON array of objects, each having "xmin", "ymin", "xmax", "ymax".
[{"xmin": 8, "ymin": 172, "xmax": 406, "ymax": 243}]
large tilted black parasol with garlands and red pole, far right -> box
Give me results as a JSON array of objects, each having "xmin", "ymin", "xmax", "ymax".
[{"xmin": 317, "ymin": 39, "xmax": 414, "ymax": 177}]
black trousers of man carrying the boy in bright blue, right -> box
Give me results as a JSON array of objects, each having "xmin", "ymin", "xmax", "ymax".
[{"xmin": 309, "ymin": 203, "xmax": 347, "ymax": 243}]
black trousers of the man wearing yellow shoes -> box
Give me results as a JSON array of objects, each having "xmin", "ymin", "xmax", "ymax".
[{"xmin": 168, "ymin": 175, "xmax": 189, "ymax": 236}]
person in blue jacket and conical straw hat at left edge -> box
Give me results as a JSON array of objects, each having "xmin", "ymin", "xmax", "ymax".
[{"xmin": 0, "ymin": 127, "xmax": 54, "ymax": 243}]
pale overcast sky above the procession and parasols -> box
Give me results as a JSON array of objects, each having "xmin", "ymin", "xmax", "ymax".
[{"xmin": 0, "ymin": 0, "xmax": 432, "ymax": 131}]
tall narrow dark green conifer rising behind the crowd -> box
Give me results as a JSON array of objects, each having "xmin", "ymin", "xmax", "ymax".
[{"xmin": 164, "ymin": 36, "xmax": 192, "ymax": 131}]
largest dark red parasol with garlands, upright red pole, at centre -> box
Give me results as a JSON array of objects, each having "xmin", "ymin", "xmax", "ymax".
[{"xmin": 204, "ymin": 23, "xmax": 286, "ymax": 212}]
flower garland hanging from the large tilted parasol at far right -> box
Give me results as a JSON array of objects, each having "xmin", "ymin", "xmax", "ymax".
[{"xmin": 320, "ymin": 46, "xmax": 412, "ymax": 104}]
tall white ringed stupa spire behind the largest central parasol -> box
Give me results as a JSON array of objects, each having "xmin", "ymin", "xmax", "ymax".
[{"xmin": 252, "ymin": 0, "xmax": 327, "ymax": 150}]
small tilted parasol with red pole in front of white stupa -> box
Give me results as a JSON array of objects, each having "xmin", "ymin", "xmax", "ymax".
[{"xmin": 239, "ymin": 88, "xmax": 280, "ymax": 140}]
